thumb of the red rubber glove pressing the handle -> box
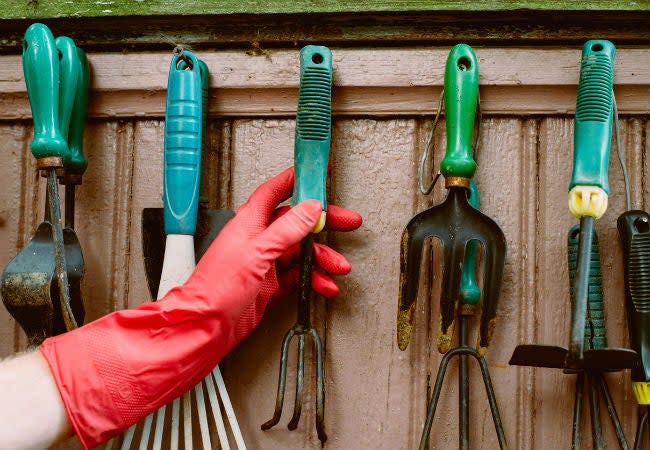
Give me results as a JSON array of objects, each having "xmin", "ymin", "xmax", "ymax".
[{"xmin": 255, "ymin": 200, "xmax": 322, "ymax": 261}]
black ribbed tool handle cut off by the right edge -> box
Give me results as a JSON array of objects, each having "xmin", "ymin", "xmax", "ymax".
[{"xmin": 617, "ymin": 211, "xmax": 650, "ymax": 386}]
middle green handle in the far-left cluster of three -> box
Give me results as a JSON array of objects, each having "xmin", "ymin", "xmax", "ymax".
[{"xmin": 55, "ymin": 36, "xmax": 81, "ymax": 146}]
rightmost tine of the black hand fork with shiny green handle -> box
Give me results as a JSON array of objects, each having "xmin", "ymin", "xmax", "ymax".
[{"xmin": 477, "ymin": 232, "xmax": 506, "ymax": 356}]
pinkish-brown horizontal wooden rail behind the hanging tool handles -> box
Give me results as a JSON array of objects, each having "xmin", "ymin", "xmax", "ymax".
[{"xmin": 0, "ymin": 48, "xmax": 650, "ymax": 120}]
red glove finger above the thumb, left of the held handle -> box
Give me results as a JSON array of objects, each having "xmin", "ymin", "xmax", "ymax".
[{"xmin": 237, "ymin": 167, "xmax": 294, "ymax": 223}]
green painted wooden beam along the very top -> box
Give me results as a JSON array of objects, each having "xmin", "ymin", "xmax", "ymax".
[{"xmin": 0, "ymin": 0, "xmax": 650, "ymax": 20}]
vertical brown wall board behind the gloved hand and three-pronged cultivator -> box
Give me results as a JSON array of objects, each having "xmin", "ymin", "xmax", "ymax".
[{"xmin": 222, "ymin": 120, "xmax": 325, "ymax": 450}]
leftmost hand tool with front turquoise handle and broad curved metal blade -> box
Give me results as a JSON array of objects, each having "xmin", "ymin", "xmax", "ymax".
[{"xmin": 2, "ymin": 23, "xmax": 80, "ymax": 346}]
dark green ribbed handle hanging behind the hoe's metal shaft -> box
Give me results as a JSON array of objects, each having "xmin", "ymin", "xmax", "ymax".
[{"xmin": 567, "ymin": 224, "xmax": 607, "ymax": 349}]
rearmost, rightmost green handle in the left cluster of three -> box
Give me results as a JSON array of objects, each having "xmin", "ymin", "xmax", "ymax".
[{"xmin": 64, "ymin": 48, "xmax": 90, "ymax": 178}]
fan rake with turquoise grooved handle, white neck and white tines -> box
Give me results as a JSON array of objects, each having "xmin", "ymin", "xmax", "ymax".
[{"xmin": 121, "ymin": 50, "xmax": 246, "ymax": 450}]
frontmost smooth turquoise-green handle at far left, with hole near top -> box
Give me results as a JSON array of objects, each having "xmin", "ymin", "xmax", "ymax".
[{"xmin": 23, "ymin": 23, "xmax": 68, "ymax": 168}]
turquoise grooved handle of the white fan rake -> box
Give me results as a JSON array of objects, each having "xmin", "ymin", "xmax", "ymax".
[{"xmin": 163, "ymin": 50, "xmax": 203, "ymax": 235}]
